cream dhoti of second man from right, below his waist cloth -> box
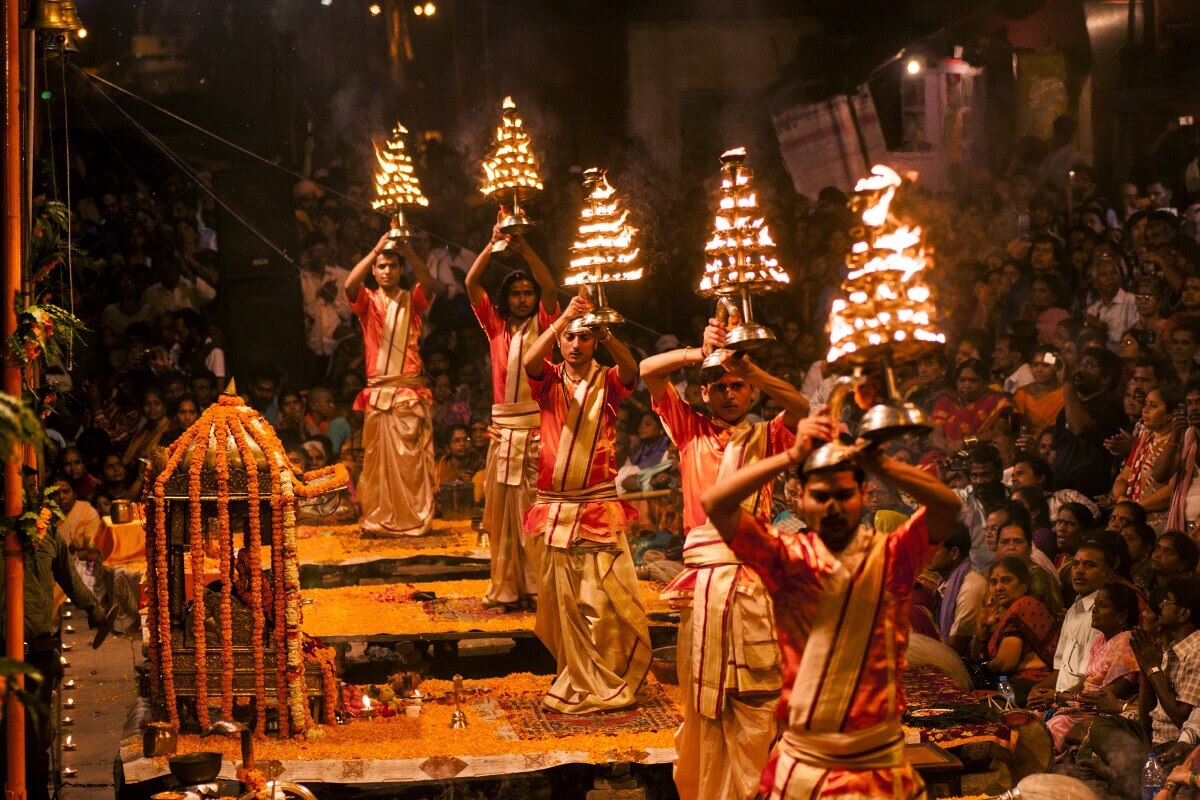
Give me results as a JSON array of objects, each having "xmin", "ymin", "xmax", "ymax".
[{"xmin": 674, "ymin": 608, "xmax": 779, "ymax": 800}]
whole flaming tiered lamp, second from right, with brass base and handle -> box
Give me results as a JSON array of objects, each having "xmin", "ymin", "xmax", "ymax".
[{"xmin": 697, "ymin": 148, "xmax": 791, "ymax": 377}]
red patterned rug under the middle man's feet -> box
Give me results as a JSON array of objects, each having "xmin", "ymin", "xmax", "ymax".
[{"xmin": 497, "ymin": 685, "xmax": 683, "ymax": 739}]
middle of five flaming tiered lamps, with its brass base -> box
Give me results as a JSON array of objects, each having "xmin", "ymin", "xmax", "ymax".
[{"xmin": 563, "ymin": 167, "xmax": 644, "ymax": 327}]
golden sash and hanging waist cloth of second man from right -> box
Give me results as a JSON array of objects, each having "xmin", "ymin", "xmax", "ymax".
[{"xmin": 683, "ymin": 421, "xmax": 780, "ymax": 720}]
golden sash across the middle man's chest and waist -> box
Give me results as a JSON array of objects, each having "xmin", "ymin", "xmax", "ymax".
[{"xmin": 547, "ymin": 362, "xmax": 617, "ymax": 548}]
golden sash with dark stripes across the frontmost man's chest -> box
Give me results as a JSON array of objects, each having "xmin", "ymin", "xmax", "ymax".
[{"xmin": 788, "ymin": 528, "xmax": 895, "ymax": 733}]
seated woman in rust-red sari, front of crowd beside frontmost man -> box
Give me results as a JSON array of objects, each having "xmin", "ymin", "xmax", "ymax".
[{"xmin": 971, "ymin": 555, "xmax": 1058, "ymax": 705}]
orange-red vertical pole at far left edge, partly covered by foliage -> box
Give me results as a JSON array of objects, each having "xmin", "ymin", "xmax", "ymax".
[{"xmin": 0, "ymin": 0, "xmax": 25, "ymax": 800}]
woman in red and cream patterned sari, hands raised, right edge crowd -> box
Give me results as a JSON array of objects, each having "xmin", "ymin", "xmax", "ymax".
[{"xmin": 1112, "ymin": 384, "xmax": 1183, "ymax": 530}]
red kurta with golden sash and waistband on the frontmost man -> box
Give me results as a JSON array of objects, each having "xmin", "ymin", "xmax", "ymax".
[{"xmin": 731, "ymin": 509, "xmax": 929, "ymax": 800}]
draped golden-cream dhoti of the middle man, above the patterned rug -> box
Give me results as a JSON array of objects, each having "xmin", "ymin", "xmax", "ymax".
[{"xmin": 535, "ymin": 534, "xmax": 650, "ymax": 714}]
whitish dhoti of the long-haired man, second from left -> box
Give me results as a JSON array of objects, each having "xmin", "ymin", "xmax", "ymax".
[{"xmin": 484, "ymin": 403, "xmax": 542, "ymax": 606}]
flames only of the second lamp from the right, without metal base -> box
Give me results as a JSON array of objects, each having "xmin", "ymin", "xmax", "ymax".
[{"xmin": 698, "ymin": 148, "xmax": 791, "ymax": 295}]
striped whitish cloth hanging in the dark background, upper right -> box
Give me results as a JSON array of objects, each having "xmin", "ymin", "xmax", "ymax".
[{"xmin": 772, "ymin": 86, "xmax": 888, "ymax": 198}]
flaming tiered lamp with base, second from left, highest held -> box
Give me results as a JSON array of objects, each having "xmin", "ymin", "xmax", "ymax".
[{"xmin": 480, "ymin": 97, "xmax": 542, "ymax": 252}]
